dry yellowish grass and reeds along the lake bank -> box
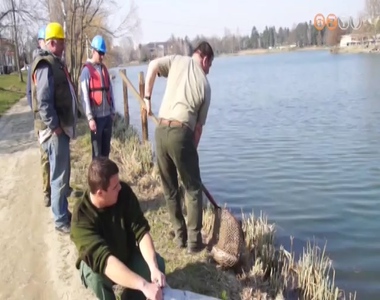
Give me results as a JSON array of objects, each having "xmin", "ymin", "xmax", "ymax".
[{"xmin": 70, "ymin": 113, "xmax": 356, "ymax": 300}]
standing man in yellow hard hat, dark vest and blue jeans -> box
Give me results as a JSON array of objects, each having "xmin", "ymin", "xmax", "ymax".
[{"xmin": 31, "ymin": 22, "xmax": 78, "ymax": 234}]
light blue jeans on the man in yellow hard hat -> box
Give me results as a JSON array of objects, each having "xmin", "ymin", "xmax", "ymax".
[{"xmin": 41, "ymin": 132, "xmax": 70, "ymax": 227}]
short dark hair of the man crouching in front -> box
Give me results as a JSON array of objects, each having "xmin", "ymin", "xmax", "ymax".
[{"xmin": 87, "ymin": 156, "xmax": 119, "ymax": 194}]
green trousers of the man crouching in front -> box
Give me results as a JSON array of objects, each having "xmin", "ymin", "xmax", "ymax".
[{"xmin": 79, "ymin": 251, "xmax": 165, "ymax": 300}]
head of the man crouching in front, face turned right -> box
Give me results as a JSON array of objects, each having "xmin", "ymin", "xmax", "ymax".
[{"xmin": 88, "ymin": 157, "xmax": 121, "ymax": 208}]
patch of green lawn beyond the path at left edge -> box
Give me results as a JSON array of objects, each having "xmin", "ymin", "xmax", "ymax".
[{"xmin": 0, "ymin": 72, "xmax": 27, "ymax": 117}]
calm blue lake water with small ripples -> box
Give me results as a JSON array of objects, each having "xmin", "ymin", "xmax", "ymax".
[{"xmin": 108, "ymin": 51, "xmax": 380, "ymax": 300}]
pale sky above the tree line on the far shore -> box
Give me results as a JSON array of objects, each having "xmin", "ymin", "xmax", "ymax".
[{"xmin": 115, "ymin": 0, "xmax": 364, "ymax": 43}]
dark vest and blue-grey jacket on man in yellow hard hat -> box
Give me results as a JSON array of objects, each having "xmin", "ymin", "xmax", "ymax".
[{"xmin": 31, "ymin": 49, "xmax": 79, "ymax": 130}]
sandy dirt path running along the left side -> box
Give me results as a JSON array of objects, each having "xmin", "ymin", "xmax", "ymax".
[{"xmin": 0, "ymin": 99, "xmax": 95, "ymax": 300}]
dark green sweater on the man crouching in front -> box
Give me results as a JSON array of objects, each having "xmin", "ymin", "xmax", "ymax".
[{"xmin": 70, "ymin": 182, "xmax": 150, "ymax": 274}]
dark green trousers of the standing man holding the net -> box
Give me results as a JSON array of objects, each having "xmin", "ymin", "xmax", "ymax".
[{"xmin": 155, "ymin": 125, "xmax": 202, "ymax": 247}]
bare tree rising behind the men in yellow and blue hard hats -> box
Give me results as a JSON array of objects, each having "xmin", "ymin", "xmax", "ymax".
[{"xmin": 40, "ymin": 0, "xmax": 140, "ymax": 89}]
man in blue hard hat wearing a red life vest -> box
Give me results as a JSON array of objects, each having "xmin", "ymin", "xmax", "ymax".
[{"xmin": 80, "ymin": 35, "xmax": 115, "ymax": 158}]
